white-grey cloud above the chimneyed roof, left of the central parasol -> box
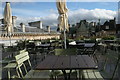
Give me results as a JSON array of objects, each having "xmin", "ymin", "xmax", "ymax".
[{"xmin": 16, "ymin": 13, "xmax": 58, "ymax": 28}]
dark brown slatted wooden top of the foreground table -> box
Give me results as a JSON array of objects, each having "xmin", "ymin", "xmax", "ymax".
[{"xmin": 36, "ymin": 55, "xmax": 97, "ymax": 70}]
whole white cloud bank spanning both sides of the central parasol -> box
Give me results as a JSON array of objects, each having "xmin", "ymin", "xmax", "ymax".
[{"xmin": 14, "ymin": 9, "xmax": 117, "ymax": 28}]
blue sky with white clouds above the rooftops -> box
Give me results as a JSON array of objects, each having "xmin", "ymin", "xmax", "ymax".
[{"xmin": 0, "ymin": 2, "xmax": 118, "ymax": 28}]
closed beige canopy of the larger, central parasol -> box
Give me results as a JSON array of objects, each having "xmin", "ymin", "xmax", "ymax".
[{"xmin": 56, "ymin": 0, "xmax": 69, "ymax": 31}]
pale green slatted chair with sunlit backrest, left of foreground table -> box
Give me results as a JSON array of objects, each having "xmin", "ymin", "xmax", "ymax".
[{"xmin": 15, "ymin": 52, "xmax": 50, "ymax": 79}]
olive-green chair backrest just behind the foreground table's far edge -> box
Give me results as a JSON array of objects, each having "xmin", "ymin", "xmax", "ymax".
[{"xmin": 55, "ymin": 48, "xmax": 77, "ymax": 55}]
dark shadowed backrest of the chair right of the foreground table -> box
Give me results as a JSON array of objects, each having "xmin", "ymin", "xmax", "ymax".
[{"xmin": 101, "ymin": 49, "xmax": 120, "ymax": 80}]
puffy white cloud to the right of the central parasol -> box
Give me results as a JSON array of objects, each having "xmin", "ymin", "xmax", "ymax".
[{"xmin": 69, "ymin": 9, "xmax": 117, "ymax": 23}]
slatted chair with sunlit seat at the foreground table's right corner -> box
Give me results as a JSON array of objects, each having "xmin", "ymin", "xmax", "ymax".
[{"xmin": 82, "ymin": 50, "xmax": 120, "ymax": 80}]
